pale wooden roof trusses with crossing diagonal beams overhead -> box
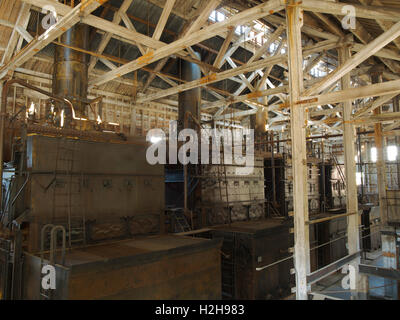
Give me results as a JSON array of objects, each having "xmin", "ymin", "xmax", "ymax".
[{"xmin": 0, "ymin": 0, "xmax": 400, "ymax": 128}]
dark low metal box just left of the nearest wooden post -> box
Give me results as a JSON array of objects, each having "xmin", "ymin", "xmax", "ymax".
[{"xmin": 210, "ymin": 219, "xmax": 294, "ymax": 300}]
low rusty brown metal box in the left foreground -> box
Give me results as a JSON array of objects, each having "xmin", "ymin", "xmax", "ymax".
[{"xmin": 24, "ymin": 236, "xmax": 221, "ymax": 300}]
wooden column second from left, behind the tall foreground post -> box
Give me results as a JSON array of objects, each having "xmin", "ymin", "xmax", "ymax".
[{"xmin": 338, "ymin": 39, "xmax": 368, "ymax": 299}]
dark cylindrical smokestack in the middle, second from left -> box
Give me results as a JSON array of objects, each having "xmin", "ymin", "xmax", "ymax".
[{"xmin": 178, "ymin": 52, "xmax": 201, "ymax": 129}]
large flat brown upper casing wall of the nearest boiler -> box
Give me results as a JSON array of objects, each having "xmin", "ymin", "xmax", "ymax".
[{"xmin": 18, "ymin": 135, "xmax": 165, "ymax": 252}]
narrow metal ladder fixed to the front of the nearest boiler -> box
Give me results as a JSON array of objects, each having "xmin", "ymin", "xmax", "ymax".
[{"xmin": 54, "ymin": 139, "xmax": 86, "ymax": 247}]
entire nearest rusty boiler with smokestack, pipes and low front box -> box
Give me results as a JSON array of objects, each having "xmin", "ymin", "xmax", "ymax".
[{"xmin": 0, "ymin": 24, "xmax": 222, "ymax": 299}]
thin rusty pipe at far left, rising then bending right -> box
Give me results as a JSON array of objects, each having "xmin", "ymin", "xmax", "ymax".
[{"xmin": 0, "ymin": 79, "xmax": 74, "ymax": 211}]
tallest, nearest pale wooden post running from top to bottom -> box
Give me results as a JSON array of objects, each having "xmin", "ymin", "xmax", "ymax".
[{"xmin": 286, "ymin": 0, "xmax": 310, "ymax": 300}]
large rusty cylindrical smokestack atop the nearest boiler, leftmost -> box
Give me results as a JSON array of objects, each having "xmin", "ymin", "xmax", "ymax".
[{"xmin": 53, "ymin": 24, "xmax": 89, "ymax": 119}]
